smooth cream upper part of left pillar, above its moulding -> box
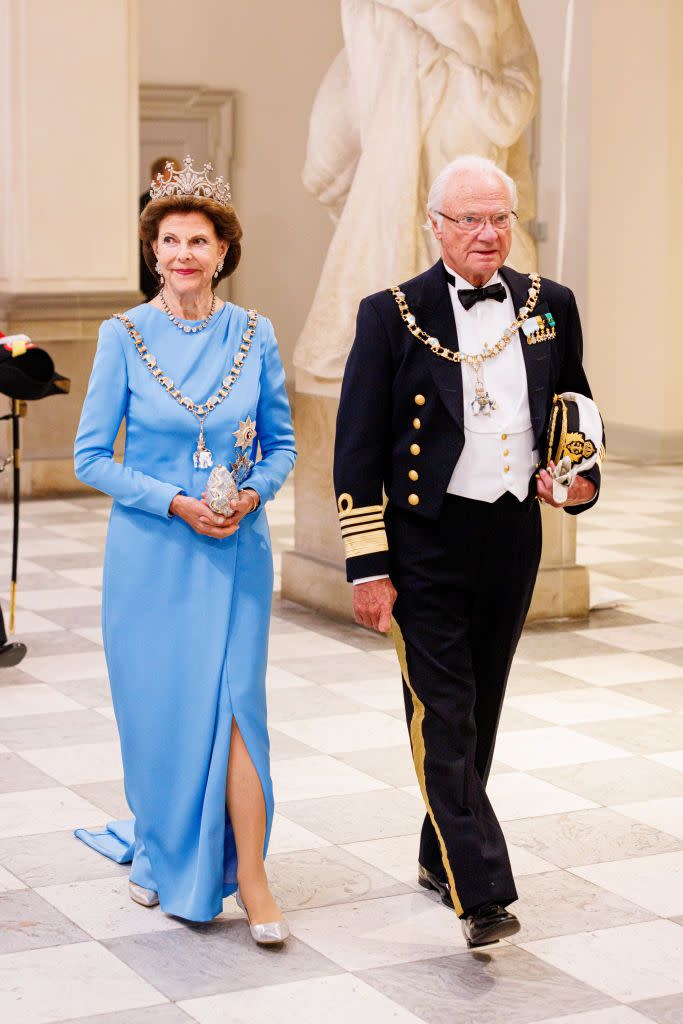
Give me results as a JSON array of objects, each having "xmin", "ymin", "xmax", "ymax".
[{"xmin": 0, "ymin": 0, "xmax": 137, "ymax": 294}]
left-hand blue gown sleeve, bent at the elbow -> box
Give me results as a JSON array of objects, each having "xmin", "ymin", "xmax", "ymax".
[{"xmin": 74, "ymin": 321, "xmax": 182, "ymax": 517}]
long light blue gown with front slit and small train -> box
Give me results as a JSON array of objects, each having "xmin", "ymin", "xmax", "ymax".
[{"xmin": 75, "ymin": 303, "xmax": 296, "ymax": 921}]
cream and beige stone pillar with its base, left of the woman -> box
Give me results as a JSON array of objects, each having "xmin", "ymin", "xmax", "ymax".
[{"xmin": 0, "ymin": 0, "xmax": 138, "ymax": 495}]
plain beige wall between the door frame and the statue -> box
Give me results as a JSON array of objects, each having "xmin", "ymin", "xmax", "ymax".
[{"xmin": 140, "ymin": 0, "xmax": 343, "ymax": 370}]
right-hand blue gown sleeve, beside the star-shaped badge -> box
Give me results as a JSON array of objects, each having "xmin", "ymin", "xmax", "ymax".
[{"xmin": 243, "ymin": 321, "xmax": 296, "ymax": 505}]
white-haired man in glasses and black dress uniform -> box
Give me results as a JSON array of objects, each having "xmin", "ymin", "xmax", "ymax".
[{"xmin": 335, "ymin": 157, "xmax": 600, "ymax": 946}]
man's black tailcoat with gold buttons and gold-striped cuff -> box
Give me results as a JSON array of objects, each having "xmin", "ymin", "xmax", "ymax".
[{"xmin": 334, "ymin": 260, "xmax": 600, "ymax": 580}]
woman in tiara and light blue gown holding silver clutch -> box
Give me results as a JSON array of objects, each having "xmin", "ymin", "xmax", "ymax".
[{"xmin": 75, "ymin": 157, "xmax": 296, "ymax": 942}]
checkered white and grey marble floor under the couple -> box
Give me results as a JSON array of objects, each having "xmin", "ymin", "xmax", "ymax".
[{"xmin": 0, "ymin": 462, "xmax": 683, "ymax": 1024}]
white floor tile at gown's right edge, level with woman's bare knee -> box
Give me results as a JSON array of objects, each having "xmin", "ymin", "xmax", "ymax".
[{"xmin": 271, "ymin": 756, "xmax": 388, "ymax": 804}]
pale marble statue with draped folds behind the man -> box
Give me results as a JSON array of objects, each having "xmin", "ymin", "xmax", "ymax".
[{"xmin": 294, "ymin": 0, "xmax": 539, "ymax": 380}]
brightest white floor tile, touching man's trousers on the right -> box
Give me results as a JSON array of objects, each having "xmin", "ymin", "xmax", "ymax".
[{"xmin": 496, "ymin": 729, "xmax": 629, "ymax": 771}]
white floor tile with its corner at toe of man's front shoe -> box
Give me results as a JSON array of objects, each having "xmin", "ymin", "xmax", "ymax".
[{"xmin": 522, "ymin": 921, "xmax": 683, "ymax": 1002}]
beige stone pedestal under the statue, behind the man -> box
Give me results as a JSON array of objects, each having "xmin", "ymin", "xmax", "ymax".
[{"xmin": 283, "ymin": 382, "xmax": 589, "ymax": 622}]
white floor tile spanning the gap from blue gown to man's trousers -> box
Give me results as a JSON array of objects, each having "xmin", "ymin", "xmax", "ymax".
[{"xmin": 272, "ymin": 712, "xmax": 405, "ymax": 754}]
